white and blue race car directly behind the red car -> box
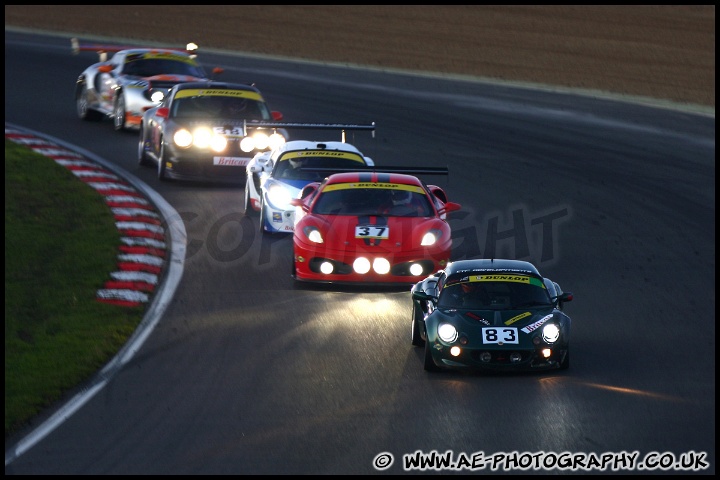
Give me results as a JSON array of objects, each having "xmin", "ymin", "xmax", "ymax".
[{"xmin": 244, "ymin": 123, "xmax": 375, "ymax": 233}]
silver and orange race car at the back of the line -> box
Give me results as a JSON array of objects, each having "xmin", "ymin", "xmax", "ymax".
[{"xmin": 72, "ymin": 38, "xmax": 222, "ymax": 130}]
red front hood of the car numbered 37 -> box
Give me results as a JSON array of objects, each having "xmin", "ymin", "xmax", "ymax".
[{"xmin": 308, "ymin": 215, "xmax": 450, "ymax": 252}]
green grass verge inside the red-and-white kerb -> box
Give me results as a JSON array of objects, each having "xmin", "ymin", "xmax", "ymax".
[{"xmin": 5, "ymin": 139, "xmax": 146, "ymax": 439}]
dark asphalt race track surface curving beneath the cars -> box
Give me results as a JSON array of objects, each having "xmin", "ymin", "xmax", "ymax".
[{"xmin": 5, "ymin": 30, "xmax": 715, "ymax": 475}]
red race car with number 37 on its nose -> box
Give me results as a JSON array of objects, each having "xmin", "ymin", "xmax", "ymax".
[{"xmin": 292, "ymin": 167, "xmax": 461, "ymax": 285}]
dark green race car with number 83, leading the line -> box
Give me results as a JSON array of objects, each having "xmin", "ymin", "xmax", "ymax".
[{"xmin": 411, "ymin": 259, "xmax": 573, "ymax": 371}]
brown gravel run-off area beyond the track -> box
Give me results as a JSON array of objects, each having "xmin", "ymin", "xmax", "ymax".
[{"xmin": 5, "ymin": 5, "xmax": 715, "ymax": 108}]
